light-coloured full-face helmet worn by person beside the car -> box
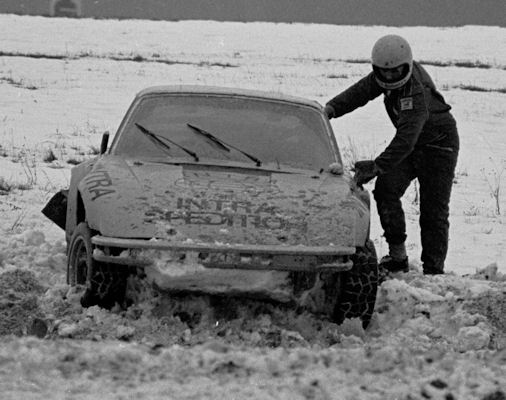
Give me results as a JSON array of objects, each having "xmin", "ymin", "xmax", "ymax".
[{"xmin": 371, "ymin": 35, "xmax": 413, "ymax": 90}]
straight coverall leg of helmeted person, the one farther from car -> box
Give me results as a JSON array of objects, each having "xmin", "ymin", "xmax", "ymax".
[{"xmin": 416, "ymin": 147, "xmax": 458, "ymax": 274}]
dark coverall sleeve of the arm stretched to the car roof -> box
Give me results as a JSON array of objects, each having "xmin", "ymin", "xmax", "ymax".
[{"xmin": 327, "ymin": 72, "xmax": 381, "ymax": 118}]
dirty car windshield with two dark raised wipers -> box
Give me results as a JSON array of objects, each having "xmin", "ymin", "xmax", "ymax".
[{"xmin": 113, "ymin": 94, "xmax": 336, "ymax": 169}]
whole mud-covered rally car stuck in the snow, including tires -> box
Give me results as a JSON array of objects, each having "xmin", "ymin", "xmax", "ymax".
[{"xmin": 43, "ymin": 85, "xmax": 378, "ymax": 327}]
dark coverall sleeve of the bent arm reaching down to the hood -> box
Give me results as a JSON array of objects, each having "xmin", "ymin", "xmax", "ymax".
[{"xmin": 374, "ymin": 90, "xmax": 429, "ymax": 173}]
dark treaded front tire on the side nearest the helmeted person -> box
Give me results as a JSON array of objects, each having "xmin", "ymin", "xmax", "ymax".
[{"xmin": 333, "ymin": 240, "xmax": 379, "ymax": 329}]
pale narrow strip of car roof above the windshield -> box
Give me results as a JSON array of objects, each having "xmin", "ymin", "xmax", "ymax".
[{"xmin": 136, "ymin": 85, "xmax": 322, "ymax": 110}]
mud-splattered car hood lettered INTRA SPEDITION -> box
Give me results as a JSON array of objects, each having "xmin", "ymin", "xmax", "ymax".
[{"xmin": 79, "ymin": 156, "xmax": 369, "ymax": 246}]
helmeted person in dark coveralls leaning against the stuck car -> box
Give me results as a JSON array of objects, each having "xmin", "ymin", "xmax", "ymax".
[{"xmin": 325, "ymin": 35, "xmax": 459, "ymax": 274}]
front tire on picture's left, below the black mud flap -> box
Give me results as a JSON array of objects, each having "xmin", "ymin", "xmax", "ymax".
[{"xmin": 67, "ymin": 222, "xmax": 128, "ymax": 309}]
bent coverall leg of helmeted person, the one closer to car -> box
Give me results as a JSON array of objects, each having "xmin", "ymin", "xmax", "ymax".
[{"xmin": 374, "ymin": 157, "xmax": 414, "ymax": 268}]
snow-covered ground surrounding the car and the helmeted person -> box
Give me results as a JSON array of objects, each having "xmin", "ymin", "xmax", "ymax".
[{"xmin": 0, "ymin": 15, "xmax": 506, "ymax": 400}]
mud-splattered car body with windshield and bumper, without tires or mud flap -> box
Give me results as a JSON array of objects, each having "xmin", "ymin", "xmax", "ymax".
[{"xmin": 43, "ymin": 86, "xmax": 378, "ymax": 326}]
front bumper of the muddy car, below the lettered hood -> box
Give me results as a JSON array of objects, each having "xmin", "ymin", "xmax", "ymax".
[{"xmin": 92, "ymin": 235, "xmax": 356, "ymax": 272}]
